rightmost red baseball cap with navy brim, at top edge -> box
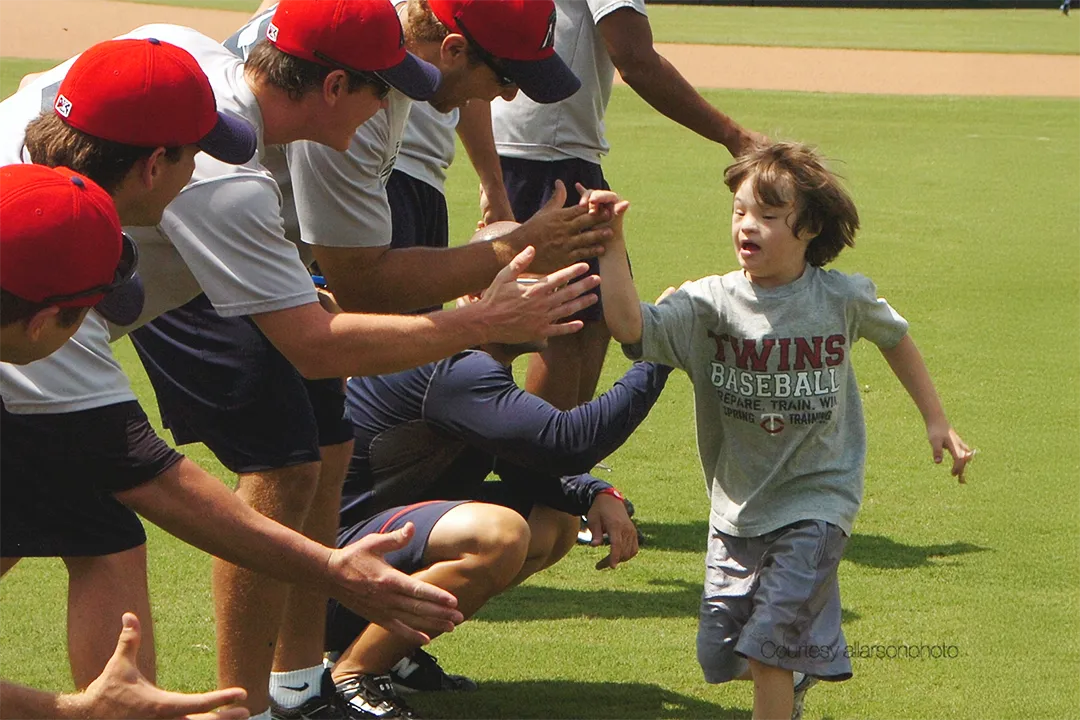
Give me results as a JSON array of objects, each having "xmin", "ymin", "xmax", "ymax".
[{"xmin": 428, "ymin": 0, "xmax": 581, "ymax": 103}]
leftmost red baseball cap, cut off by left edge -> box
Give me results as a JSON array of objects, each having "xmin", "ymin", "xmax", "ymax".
[{"xmin": 0, "ymin": 164, "xmax": 144, "ymax": 325}]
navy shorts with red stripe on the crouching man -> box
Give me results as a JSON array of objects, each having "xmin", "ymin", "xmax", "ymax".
[{"xmin": 326, "ymin": 500, "xmax": 470, "ymax": 652}]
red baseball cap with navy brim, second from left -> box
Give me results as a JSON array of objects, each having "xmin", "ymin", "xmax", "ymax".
[{"xmin": 53, "ymin": 38, "xmax": 257, "ymax": 165}]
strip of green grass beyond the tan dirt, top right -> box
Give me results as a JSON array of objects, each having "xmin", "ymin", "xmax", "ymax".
[{"xmin": 649, "ymin": 2, "xmax": 1080, "ymax": 54}]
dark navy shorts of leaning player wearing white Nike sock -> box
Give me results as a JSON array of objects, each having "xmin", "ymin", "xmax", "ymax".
[{"xmin": 131, "ymin": 295, "xmax": 352, "ymax": 473}]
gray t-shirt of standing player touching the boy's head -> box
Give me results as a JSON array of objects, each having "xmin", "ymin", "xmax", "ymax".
[{"xmin": 491, "ymin": 0, "xmax": 646, "ymax": 163}]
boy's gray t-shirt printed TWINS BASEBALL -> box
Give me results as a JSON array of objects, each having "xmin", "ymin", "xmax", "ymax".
[{"xmin": 624, "ymin": 267, "xmax": 907, "ymax": 538}]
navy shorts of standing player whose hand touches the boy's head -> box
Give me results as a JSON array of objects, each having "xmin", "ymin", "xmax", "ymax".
[{"xmin": 499, "ymin": 157, "xmax": 610, "ymax": 323}]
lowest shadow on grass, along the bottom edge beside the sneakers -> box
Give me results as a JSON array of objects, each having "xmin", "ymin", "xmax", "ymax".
[{"xmin": 409, "ymin": 680, "xmax": 751, "ymax": 720}]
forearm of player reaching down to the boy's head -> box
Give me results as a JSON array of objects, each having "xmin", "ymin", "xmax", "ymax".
[{"xmin": 619, "ymin": 51, "xmax": 744, "ymax": 154}]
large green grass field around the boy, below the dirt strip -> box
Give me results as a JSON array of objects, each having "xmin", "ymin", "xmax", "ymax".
[{"xmin": 0, "ymin": 4, "xmax": 1080, "ymax": 720}]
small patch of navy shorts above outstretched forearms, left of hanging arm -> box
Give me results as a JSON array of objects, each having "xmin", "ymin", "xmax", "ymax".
[{"xmin": 387, "ymin": 169, "xmax": 450, "ymax": 313}]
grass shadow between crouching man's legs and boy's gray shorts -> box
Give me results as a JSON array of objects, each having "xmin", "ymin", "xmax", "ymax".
[{"xmin": 476, "ymin": 579, "xmax": 860, "ymax": 623}]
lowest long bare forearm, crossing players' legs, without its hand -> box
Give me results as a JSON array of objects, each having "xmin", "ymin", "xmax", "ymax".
[{"xmin": 117, "ymin": 460, "xmax": 334, "ymax": 595}]
